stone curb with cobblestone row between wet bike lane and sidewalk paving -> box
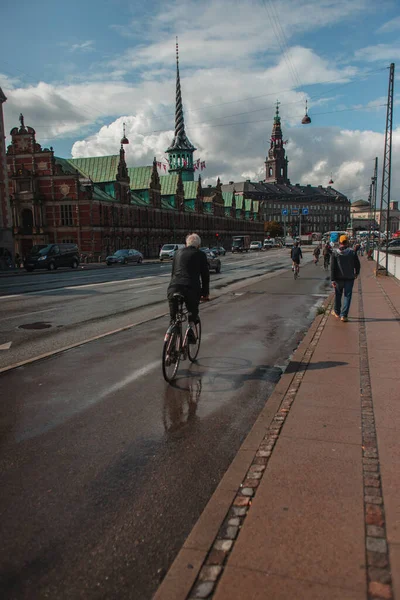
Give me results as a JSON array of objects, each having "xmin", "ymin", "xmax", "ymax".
[{"xmin": 153, "ymin": 294, "xmax": 333, "ymax": 600}]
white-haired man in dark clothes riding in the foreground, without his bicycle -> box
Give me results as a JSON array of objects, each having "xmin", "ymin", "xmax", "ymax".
[{"xmin": 168, "ymin": 233, "xmax": 210, "ymax": 344}]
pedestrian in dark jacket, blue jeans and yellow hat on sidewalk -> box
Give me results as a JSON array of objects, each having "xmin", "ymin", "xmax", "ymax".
[{"xmin": 331, "ymin": 235, "xmax": 361, "ymax": 321}]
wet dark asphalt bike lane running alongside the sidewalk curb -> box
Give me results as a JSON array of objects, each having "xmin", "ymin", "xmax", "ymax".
[{"xmin": 0, "ymin": 255, "xmax": 327, "ymax": 600}]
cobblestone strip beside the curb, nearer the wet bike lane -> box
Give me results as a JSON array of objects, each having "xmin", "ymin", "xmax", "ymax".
[{"xmin": 187, "ymin": 303, "xmax": 332, "ymax": 600}]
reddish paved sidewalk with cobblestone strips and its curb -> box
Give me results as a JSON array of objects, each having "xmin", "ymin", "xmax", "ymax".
[{"xmin": 154, "ymin": 259, "xmax": 400, "ymax": 600}]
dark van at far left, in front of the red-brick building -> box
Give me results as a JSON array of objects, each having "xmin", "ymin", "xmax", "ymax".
[{"xmin": 24, "ymin": 244, "xmax": 80, "ymax": 272}]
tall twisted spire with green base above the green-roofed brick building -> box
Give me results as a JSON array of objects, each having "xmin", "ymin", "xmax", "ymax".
[{"xmin": 166, "ymin": 38, "xmax": 196, "ymax": 181}]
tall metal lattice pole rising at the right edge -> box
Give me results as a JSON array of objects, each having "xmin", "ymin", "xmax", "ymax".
[{"xmin": 376, "ymin": 63, "xmax": 394, "ymax": 275}]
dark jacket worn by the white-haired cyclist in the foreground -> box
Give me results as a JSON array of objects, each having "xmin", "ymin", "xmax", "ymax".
[{"xmin": 168, "ymin": 246, "xmax": 210, "ymax": 296}]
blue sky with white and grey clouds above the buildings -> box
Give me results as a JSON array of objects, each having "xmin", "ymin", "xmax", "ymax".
[{"xmin": 0, "ymin": 0, "xmax": 400, "ymax": 200}]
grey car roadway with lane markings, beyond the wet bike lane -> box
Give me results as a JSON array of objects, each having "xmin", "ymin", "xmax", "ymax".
[{"xmin": 0, "ymin": 250, "xmax": 296, "ymax": 368}]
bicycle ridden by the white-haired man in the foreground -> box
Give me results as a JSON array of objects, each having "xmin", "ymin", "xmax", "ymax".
[{"xmin": 162, "ymin": 293, "xmax": 201, "ymax": 383}]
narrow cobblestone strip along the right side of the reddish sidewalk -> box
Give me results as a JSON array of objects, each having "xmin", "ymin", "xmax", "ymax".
[{"xmin": 358, "ymin": 280, "xmax": 393, "ymax": 600}]
